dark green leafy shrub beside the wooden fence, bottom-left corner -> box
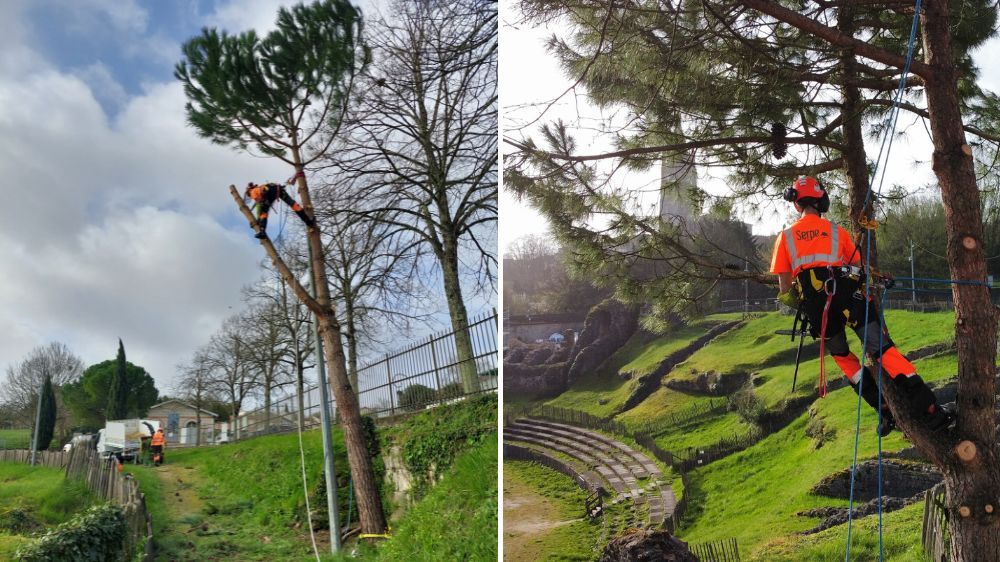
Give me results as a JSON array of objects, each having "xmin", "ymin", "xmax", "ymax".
[{"xmin": 14, "ymin": 504, "xmax": 128, "ymax": 562}]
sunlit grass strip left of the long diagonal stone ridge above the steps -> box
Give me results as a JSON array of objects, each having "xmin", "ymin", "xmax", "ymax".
[{"xmin": 548, "ymin": 316, "xmax": 720, "ymax": 417}]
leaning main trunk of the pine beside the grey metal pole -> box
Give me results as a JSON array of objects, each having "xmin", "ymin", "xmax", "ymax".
[{"xmin": 292, "ymin": 160, "xmax": 386, "ymax": 534}]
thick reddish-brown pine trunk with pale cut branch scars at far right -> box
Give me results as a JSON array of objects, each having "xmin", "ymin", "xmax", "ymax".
[{"xmin": 910, "ymin": 0, "xmax": 1000, "ymax": 562}]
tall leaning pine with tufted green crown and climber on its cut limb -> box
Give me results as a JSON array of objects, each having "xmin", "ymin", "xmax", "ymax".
[{"xmin": 174, "ymin": 0, "xmax": 386, "ymax": 534}]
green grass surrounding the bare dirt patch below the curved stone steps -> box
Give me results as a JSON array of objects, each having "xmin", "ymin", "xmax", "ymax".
[{"xmin": 503, "ymin": 461, "xmax": 597, "ymax": 561}]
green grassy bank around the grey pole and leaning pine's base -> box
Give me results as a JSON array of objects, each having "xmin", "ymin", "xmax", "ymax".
[{"xmin": 130, "ymin": 396, "xmax": 497, "ymax": 561}]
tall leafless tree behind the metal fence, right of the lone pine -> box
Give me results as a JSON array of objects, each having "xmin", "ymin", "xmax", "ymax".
[{"xmin": 328, "ymin": 0, "xmax": 498, "ymax": 392}]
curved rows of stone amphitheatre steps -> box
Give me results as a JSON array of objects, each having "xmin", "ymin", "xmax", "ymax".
[{"xmin": 504, "ymin": 418, "xmax": 677, "ymax": 528}]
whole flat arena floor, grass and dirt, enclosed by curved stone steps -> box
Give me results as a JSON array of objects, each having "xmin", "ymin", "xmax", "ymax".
[{"xmin": 503, "ymin": 461, "xmax": 600, "ymax": 561}]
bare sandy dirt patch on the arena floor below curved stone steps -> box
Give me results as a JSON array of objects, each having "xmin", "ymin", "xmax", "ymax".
[{"xmin": 503, "ymin": 464, "xmax": 579, "ymax": 561}]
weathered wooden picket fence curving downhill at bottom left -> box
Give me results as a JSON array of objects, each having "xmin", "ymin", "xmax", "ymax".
[{"xmin": 0, "ymin": 440, "xmax": 153, "ymax": 562}]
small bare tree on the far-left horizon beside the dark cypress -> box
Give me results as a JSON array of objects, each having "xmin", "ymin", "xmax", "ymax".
[{"xmin": 0, "ymin": 342, "xmax": 83, "ymax": 425}]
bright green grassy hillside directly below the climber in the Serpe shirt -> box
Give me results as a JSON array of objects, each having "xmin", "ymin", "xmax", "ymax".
[{"xmin": 663, "ymin": 312, "xmax": 955, "ymax": 560}]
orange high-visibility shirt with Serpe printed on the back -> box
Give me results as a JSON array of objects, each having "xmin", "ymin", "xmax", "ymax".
[{"xmin": 771, "ymin": 215, "xmax": 860, "ymax": 276}]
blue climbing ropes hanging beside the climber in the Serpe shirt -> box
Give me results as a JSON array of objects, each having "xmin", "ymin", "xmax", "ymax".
[{"xmin": 844, "ymin": 0, "xmax": 921, "ymax": 562}]
